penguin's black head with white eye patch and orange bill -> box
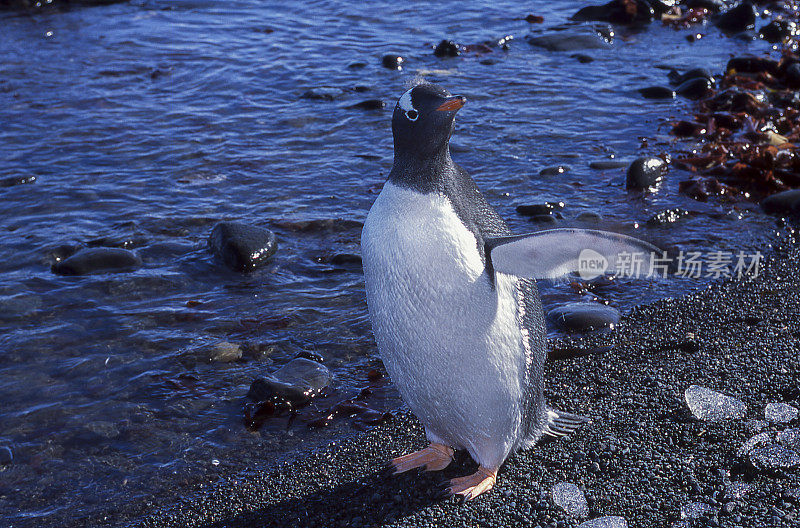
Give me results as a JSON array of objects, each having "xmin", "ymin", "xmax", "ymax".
[{"xmin": 392, "ymin": 83, "xmax": 467, "ymax": 158}]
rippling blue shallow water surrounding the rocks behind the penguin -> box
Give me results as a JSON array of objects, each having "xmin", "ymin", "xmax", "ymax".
[{"xmin": 0, "ymin": 0, "xmax": 775, "ymax": 526}]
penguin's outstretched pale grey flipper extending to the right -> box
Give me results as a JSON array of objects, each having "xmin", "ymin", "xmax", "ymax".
[{"xmin": 486, "ymin": 228, "xmax": 666, "ymax": 279}]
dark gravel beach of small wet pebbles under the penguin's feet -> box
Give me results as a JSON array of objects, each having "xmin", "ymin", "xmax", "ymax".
[{"xmin": 128, "ymin": 235, "xmax": 800, "ymax": 527}]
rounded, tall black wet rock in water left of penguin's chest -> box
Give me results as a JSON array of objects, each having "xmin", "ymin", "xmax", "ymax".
[{"xmin": 208, "ymin": 222, "xmax": 278, "ymax": 271}]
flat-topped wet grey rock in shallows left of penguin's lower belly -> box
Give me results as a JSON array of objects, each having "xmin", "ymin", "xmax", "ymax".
[{"xmin": 247, "ymin": 358, "xmax": 331, "ymax": 405}]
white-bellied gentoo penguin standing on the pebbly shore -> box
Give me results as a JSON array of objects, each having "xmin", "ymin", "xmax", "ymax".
[{"xmin": 361, "ymin": 83, "xmax": 656, "ymax": 500}]
